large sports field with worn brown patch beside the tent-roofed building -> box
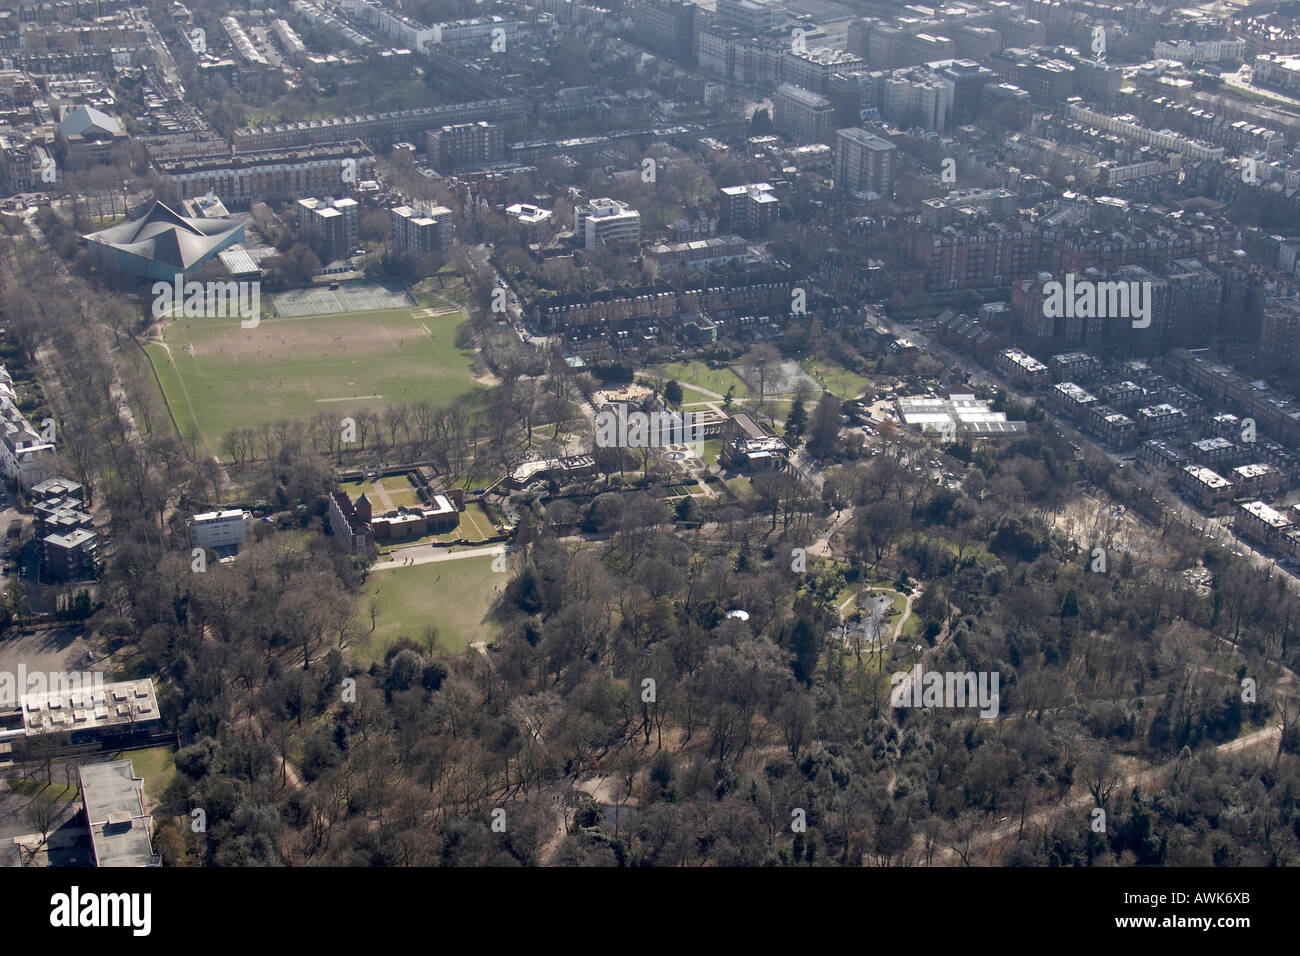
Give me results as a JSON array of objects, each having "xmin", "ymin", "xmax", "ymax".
[{"xmin": 146, "ymin": 308, "xmax": 480, "ymax": 455}]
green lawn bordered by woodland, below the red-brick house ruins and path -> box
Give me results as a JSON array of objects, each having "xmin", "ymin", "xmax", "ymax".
[{"xmin": 354, "ymin": 555, "xmax": 508, "ymax": 661}]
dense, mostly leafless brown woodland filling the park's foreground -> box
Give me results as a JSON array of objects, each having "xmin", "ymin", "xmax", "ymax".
[{"xmin": 3, "ymin": 214, "xmax": 1300, "ymax": 866}]
